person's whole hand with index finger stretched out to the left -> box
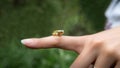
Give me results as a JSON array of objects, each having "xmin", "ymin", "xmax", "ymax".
[{"xmin": 21, "ymin": 27, "xmax": 120, "ymax": 68}]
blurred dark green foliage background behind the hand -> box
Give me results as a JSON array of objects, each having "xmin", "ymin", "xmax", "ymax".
[{"xmin": 0, "ymin": 0, "xmax": 110, "ymax": 68}]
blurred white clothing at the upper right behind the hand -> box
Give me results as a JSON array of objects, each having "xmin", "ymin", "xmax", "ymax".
[{"xmin": 105, "ymin": 0, "xmax": 120, "ymax": 29}]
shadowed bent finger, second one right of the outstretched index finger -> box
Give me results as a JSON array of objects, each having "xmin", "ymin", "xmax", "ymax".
[{"xmin": 95, "ymin": 53, "xmax": 115, "ymax": 68}]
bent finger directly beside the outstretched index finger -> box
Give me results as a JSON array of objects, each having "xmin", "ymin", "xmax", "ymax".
[{"xmin": 71, "ymin": 48, "xmax": 96, "ymax": 68}]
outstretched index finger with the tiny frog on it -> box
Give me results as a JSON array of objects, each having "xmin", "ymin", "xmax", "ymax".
[{"xmin": 21, "ymin": 36, "xmax": 85, "ymax": 50}]
